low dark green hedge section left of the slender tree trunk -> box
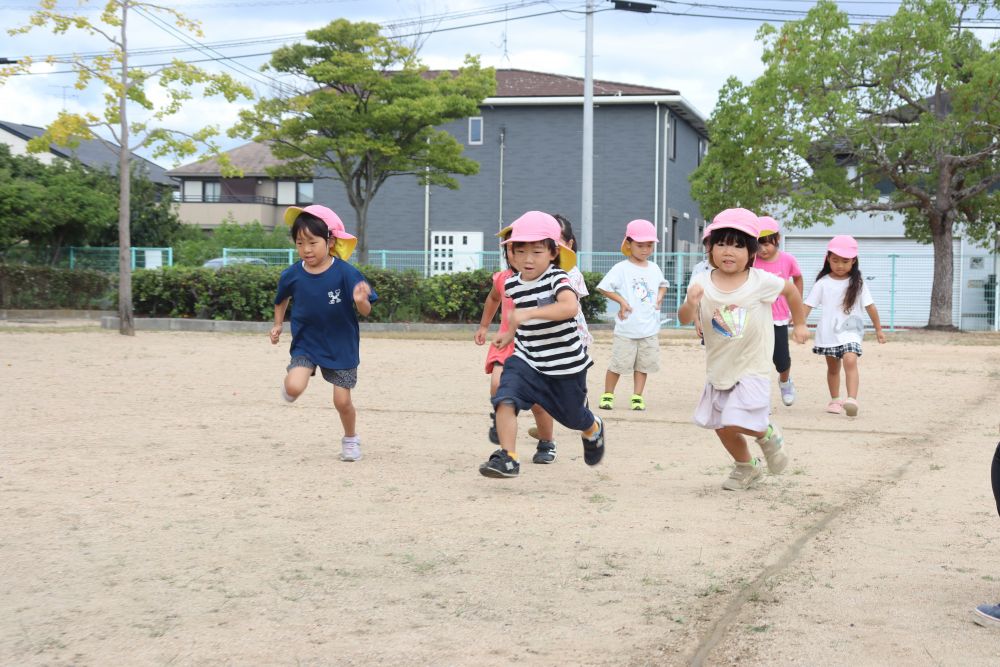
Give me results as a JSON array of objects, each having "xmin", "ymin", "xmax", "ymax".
[{"xmin": 0, "ymin": 264, "xmax": 116, "ymax": 310}]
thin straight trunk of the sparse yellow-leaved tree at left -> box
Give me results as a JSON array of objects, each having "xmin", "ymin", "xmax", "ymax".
[{"xmin": 118, "ymin": 2, "xmax": 135, "ymax": 336}]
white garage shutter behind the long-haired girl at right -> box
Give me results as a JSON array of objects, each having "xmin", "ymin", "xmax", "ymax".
[{"xmin": 782, "ymin": 236, "xmax": 962, "ymax": 328}]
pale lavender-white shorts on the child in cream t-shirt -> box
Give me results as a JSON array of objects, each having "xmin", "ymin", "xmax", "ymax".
[{"xmin": 692, "ymin": 375, "xmax": 771, "ymax": 431}]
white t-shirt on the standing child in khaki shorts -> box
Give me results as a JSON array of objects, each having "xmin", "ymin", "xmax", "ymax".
[{"xmin": 597, "ymin": 259, "xmax": 670, "ymax": 338}]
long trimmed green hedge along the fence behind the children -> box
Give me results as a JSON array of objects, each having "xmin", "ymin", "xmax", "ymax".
[{"xmin": 0, "ymin": 264, "xmax": 606, "ymax": 322}]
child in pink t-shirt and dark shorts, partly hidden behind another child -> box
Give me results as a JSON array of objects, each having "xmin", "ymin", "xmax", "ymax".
[{"xmin": 753, "ymin": 215, "xmax": 802, "ymax": 405}]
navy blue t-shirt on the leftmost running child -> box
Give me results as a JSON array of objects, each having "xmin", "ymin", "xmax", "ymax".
[{"xmin": 274, "ymin": 259, "xmax": 378, "ymax": 370}]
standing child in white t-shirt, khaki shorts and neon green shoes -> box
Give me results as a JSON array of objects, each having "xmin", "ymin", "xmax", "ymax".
[{"xmin": 597, "ymin": 220, "xmax": 670, "ymax": 410}]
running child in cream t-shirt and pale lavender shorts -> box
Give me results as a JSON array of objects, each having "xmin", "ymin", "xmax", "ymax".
[{"xmin": 677, "ymin": 208, "xmax": 808, "ymax": 491}]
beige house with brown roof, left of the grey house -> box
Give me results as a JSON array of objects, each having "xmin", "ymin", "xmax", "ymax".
[{"xmin": 167, "ymin": 142, "xmax": 313, "ymax": 229}]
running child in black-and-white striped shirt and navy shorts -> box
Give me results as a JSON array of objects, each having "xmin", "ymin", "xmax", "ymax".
[{"xmin": 479, "ymin": 211, "xmax": 604, "ymax": 477}]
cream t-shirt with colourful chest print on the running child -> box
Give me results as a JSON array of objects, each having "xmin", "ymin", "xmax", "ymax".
[{"xmin": 692, "ymin": 268, "xmax": 785, "ymax": 391}]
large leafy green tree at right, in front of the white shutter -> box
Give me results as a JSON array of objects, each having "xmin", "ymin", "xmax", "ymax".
[{"xmin": 691, "ymin": 0, "xmax": 1000, "ymax": 328}]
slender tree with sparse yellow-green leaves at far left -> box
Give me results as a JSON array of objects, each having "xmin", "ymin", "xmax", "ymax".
[{"xmin": 0, "ymin": 0, "xmax": 251, "ymax": 336}]
